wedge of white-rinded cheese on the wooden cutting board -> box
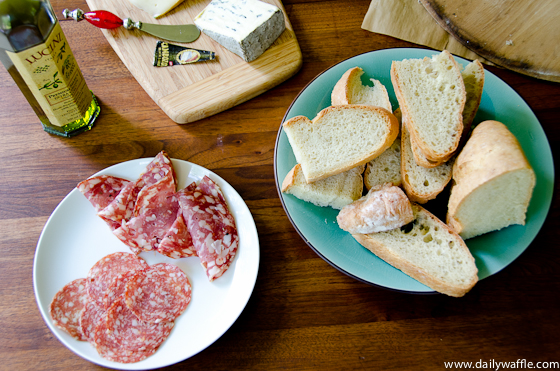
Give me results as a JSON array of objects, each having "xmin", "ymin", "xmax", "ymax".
[{"xmin": 194, "ymin": 0, "xmax": 286, "ymax": 62}]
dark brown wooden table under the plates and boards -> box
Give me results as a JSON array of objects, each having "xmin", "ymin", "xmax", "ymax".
[{"xmin": 0, "ymin": 0, "xmax": 560, "ymax": 371}]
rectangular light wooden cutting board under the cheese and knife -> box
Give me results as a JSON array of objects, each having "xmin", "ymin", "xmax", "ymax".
[{"xmin": 84, "ymin": 0, "xmax": 302, "ymax": 124}]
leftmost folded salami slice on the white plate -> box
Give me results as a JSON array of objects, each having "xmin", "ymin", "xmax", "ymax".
[{"xmin": 77, "ymin": 175, "xmax": 131, "ymax": 211}]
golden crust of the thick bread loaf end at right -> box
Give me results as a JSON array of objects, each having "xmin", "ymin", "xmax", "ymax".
[{"xmin": 446, "ymin": 120, "xmax": 536, "ymax": 233}]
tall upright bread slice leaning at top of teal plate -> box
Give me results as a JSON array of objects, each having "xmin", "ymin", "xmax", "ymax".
[{"xmin": 391, "ymin": 50, "xmax": 466, "ymax": 161}]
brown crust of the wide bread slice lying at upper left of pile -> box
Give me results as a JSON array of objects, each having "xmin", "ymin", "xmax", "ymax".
[{"xmin": 283, "ymin": 104, "xmax": 399, "ymax": 183}]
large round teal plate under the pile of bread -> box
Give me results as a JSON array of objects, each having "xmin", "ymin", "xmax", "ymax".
[{"xmin": 274, "ymin": 48, "xmax": 554, "ymax": 293}]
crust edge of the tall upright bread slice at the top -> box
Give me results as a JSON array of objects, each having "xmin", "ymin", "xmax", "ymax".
[{"xmin": 391, "ymin": 50, "xmax": 466, "ymax": 162}]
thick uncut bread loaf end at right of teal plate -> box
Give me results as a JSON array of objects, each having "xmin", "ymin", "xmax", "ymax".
[{"xmin": 447, "ymin": 121, "xmax": 536, "ymax": 239}]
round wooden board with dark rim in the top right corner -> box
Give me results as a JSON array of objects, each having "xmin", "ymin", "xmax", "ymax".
[{"xmin": 420, "ymin": 0, "xmax": 560, "ymax": 82}]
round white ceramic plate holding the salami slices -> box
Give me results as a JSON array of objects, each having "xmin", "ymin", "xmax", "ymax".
[{"xmin": 33, "ymin": 158, "xmax": 260, "ymax": 370}]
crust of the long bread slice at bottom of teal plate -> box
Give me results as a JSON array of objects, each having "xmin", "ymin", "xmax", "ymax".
[{"xmin": 352, "ymin": 204, "xmax": 478, "ymax": 297}]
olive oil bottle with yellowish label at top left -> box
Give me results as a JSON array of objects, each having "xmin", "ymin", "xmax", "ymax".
[{"xmin": 0, "ymin": 0, "xmax": 100, "ymax": 137}]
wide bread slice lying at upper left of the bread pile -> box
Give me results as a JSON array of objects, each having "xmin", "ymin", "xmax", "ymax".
[{"xmin": 283, "ymin": 104, "xmax": 399, "ymax": 183}]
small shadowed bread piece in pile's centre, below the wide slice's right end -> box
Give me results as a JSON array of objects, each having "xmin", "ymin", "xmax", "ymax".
[{"xmin": 364, "ymin": 137, "xmax": 402, "ymax": 190}]
